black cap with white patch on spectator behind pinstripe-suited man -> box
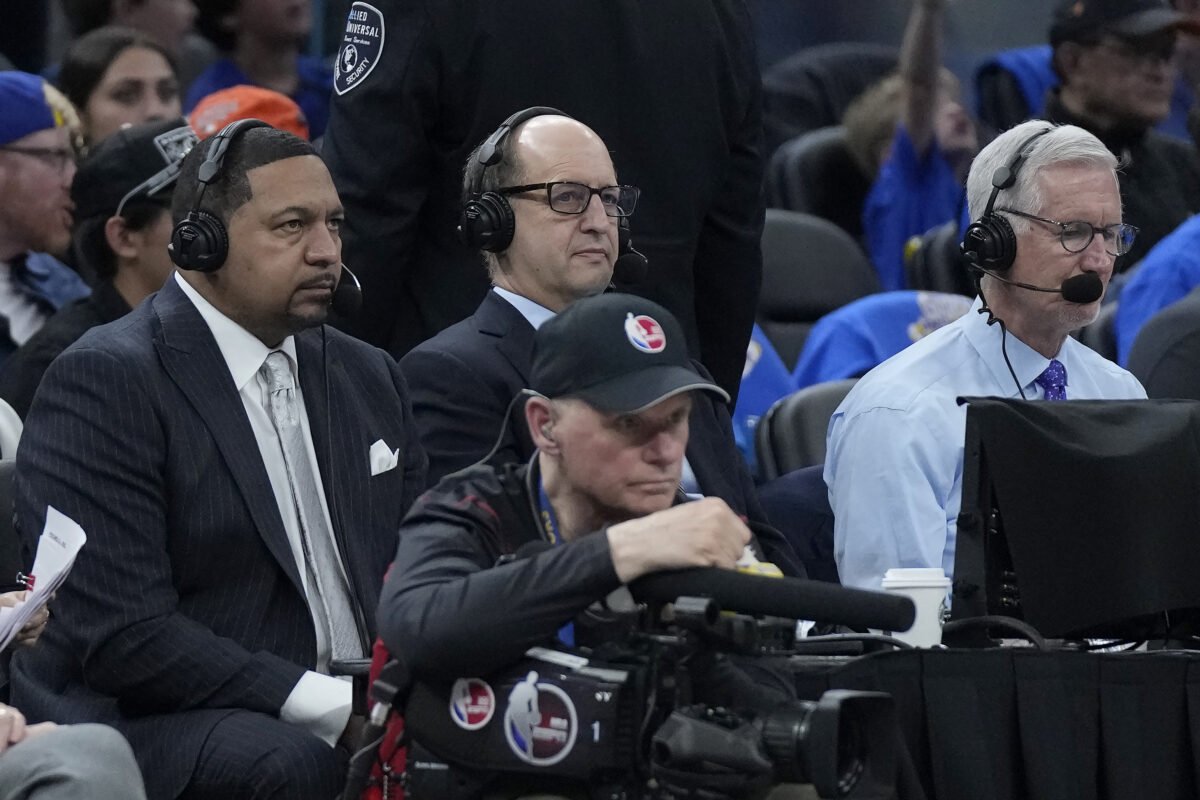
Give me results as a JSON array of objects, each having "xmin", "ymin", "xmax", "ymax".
[{"xmin": 71, "ymin": 118, "xmax": 197, "ymax": 219}]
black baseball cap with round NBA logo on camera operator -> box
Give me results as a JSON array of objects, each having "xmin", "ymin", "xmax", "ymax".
[{"xmin": 529, "ymin": 293, "xmax": 730, "ymax": 414}]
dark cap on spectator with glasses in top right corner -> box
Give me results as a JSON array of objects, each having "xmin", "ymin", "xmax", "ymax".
[{"xmin": 1050, "ymin": 0, "xmax": 1200, "ymax": 47}]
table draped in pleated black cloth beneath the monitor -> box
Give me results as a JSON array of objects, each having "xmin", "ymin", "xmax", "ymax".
[{"xmin": 793, "ymin": 648, "xmax": 1200, "ymax": 800}]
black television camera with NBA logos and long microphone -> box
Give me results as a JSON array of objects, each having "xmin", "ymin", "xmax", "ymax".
[{"xmin": 347, "ymin": 570, "xmax": 913, "ymax": 800}]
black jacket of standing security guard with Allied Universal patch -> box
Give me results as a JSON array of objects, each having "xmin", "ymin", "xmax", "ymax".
[{"xmin": 323, "ymin": 0, "xmax": 763, "ymax": 396}]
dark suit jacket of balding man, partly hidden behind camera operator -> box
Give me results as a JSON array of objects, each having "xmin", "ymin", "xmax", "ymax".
[{"xmin": 400, "ymin": 291, "xmax": 800, "ymax": 573}]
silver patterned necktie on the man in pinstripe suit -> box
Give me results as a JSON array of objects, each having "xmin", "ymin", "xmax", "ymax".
[{"xmin": 259, "ymin": 350, "xmax": 362, "ymax": 660}]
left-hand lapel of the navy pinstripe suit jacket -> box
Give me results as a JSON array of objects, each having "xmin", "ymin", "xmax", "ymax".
[{"xmin": 152, "ymin": 279, "xmax": 304, "ymax": 595}]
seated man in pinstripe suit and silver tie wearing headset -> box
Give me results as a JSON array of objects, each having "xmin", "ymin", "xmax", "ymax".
[{"xmin": 13, "ymin": 126, "xmax": 426, "ymax": 800}]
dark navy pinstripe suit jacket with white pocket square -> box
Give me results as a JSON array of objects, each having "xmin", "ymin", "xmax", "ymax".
[{"xmin": 12, "ymin": 281, "xmax": 425, "ymax": 798}]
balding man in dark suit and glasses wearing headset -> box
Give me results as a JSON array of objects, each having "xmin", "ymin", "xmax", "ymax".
[{"xmin": 400, "ymin": 107, "xmax": 802, "ymax": 573}]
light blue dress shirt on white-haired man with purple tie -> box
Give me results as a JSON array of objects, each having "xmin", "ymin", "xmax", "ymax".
[{"xmin": 824, "ymin": 297, "xmax": 1146, "ymax": 590}]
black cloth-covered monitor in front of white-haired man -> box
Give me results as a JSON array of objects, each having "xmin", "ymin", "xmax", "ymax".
[{"xmin": 950, "ymin": 398, "xmax": 1200, "ymax": 640}]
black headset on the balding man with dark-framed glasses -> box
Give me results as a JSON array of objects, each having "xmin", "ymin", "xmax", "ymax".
[{"xmin": 457, "ymin": 106, "xmax": 570, "ymax": 253}]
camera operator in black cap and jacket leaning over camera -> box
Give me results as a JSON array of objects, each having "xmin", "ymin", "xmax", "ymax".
[{"xmin": 378, "ymin": 294, "xmax": 794, "ymax": 796}]
